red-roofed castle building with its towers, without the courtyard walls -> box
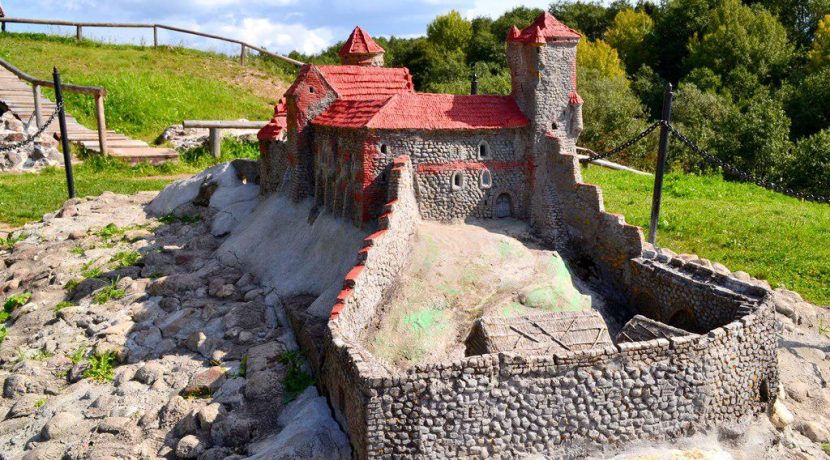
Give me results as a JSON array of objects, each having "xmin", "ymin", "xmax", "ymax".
[{"xmin": 261, "ymin": 13, "xmax": 582, "ymax": 237}]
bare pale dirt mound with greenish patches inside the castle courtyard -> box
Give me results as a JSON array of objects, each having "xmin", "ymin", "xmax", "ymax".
[{"xmin": 366, "ymin": 219, "xmax": 616, "ymax": 367}]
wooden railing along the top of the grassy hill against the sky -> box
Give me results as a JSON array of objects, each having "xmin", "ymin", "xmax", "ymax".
[{"xmin": 0, "ymin": 18, "xmax": 303, "ymax": 66}]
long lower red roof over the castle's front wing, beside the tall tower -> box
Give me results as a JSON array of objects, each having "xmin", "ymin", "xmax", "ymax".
[{"xmin": 311, "ymin": 93, "xmax": 528, "ymax": 130}]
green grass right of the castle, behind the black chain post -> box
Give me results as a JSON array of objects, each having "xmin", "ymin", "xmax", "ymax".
[{"xmin": 583, "ymin": 167, "xmax": 830, "ymax": 305}]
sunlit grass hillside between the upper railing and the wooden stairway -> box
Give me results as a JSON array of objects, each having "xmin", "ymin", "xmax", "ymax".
[{"xmin": 0, "ymin": 34, "xmax": 290, "ymax": 141}]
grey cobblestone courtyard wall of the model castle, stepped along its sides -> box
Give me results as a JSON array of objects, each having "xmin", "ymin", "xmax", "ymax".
[{"xmin": 310, "ymin": 139, "xmax": 778, "ymax": 458}]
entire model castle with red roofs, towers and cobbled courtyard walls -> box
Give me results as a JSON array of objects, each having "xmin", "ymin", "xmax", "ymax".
[{"xmin": 259, "ymin": 13, "xmax": 778, "ymax": 458}]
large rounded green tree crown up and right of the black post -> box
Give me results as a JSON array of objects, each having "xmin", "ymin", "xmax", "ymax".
[{"xmin": 684, "ymin": 0, "xmax": 794, "ymax": 85}]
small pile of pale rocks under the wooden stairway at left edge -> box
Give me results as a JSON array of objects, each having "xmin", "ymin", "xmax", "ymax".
[{"xmin": 0, "ymin": 108, "xmax": 63, "ymax": 171}]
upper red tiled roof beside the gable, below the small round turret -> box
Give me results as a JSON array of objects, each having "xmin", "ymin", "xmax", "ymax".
[{"xmin": 318, "ymin": 65, "xmax": 414, "ymax": 99}]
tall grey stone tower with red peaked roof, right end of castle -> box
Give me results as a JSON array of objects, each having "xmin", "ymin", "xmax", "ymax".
[{"xmin": 507, "ymin": 12, "xmax": 582, "ymax": 152}]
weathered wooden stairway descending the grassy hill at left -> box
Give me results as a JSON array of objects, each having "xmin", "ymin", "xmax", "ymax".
[{"xmin": 0, "ymin": 67, "xmax": 179, "ymax": 163}]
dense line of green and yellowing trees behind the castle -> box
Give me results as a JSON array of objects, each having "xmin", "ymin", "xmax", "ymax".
[{"xmin": 291, "ymin": 0, "xmax": 830, "ymax": 194}]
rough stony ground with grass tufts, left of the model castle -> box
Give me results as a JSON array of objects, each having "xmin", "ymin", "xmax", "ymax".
[{"xmin": 0, "ymin": 194, "xmax": 351, "ymax": 459}]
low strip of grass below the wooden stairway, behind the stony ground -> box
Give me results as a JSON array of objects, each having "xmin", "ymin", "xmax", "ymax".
[{"xmin": 0, "ymin": 138, "xmax": 259, "ymax": 228}]
